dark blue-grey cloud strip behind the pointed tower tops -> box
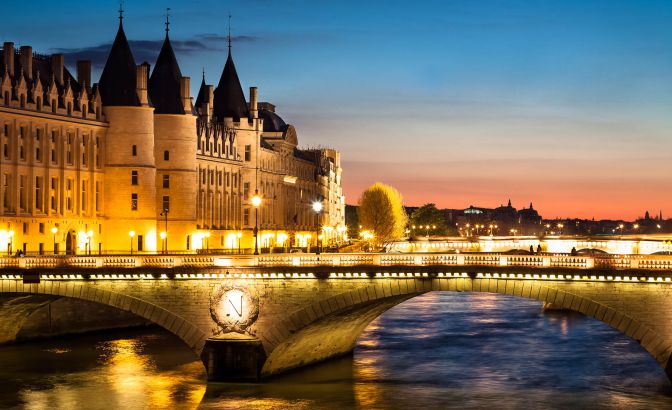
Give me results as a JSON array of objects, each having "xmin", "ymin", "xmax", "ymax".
[{"xmin": 51, "ymin": 33, "xmax": 259, "ymax": 68}]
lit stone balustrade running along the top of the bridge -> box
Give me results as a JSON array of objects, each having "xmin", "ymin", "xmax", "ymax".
[{"xmin": 0, "ymin": 253, "xmax": 672, "ymax": 271}]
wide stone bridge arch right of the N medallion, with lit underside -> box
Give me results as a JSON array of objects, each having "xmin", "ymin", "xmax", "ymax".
[{"xmin": 262, "ymin": 278, "xmax": 672, "ymax": 380}]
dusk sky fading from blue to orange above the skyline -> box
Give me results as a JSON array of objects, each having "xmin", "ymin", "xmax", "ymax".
[{"xmin": 0, "ymin": 0, "xmax": 672, "ymax": 219}]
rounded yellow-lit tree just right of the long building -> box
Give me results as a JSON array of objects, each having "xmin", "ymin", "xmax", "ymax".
[{"xmin": 357, "ymin": 182, "xmax": 408, "ymax": 244}]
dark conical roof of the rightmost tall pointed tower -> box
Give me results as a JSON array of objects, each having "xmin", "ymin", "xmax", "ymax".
[{"xmin": 213, "ymin": 48, "xmax": 248, "ymax": 121}]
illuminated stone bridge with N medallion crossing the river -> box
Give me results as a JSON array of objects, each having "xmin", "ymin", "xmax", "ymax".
[{"xmin": 0, "ymin": 254, "xmax": 672, "ymax": 379}]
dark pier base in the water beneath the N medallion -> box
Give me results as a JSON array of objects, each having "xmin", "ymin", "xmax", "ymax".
[{"xmin": 201, "ymin": 338, "xmax": 266, "ymax": 382}]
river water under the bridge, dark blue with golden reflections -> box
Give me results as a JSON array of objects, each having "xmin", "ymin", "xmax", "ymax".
[{"xmin": 0, "ymin": 292, "xmax": 672, "ymax": 409}]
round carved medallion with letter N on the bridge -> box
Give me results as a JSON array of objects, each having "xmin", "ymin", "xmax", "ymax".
[{"xmin": 210, "ymin": 285, "xmax": 259, "ymax": 334}]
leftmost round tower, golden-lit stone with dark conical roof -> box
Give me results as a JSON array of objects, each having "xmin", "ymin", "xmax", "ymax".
[{"xmin": 100, "ymin": 18, "xmax": 157, "ymax": 253}]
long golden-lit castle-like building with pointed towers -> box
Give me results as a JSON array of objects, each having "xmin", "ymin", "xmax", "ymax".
[{"xmin": 0, "ymin": 17, "xmax": 345, "ymax": 253}]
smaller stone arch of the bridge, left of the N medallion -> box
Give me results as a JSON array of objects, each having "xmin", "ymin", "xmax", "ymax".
[{"xmin": 0, "ymin": 281, "xmax": 207, "ymax": 357}]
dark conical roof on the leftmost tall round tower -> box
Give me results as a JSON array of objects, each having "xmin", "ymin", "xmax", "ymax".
[{"xmin": 100, "ymin": 18, "xmax": 140, "ymax": 107}]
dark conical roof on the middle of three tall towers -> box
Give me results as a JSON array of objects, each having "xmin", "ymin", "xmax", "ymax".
[{"xmin": 148, "ymin": 32, "xmax": 185, "ymax": 114}]
